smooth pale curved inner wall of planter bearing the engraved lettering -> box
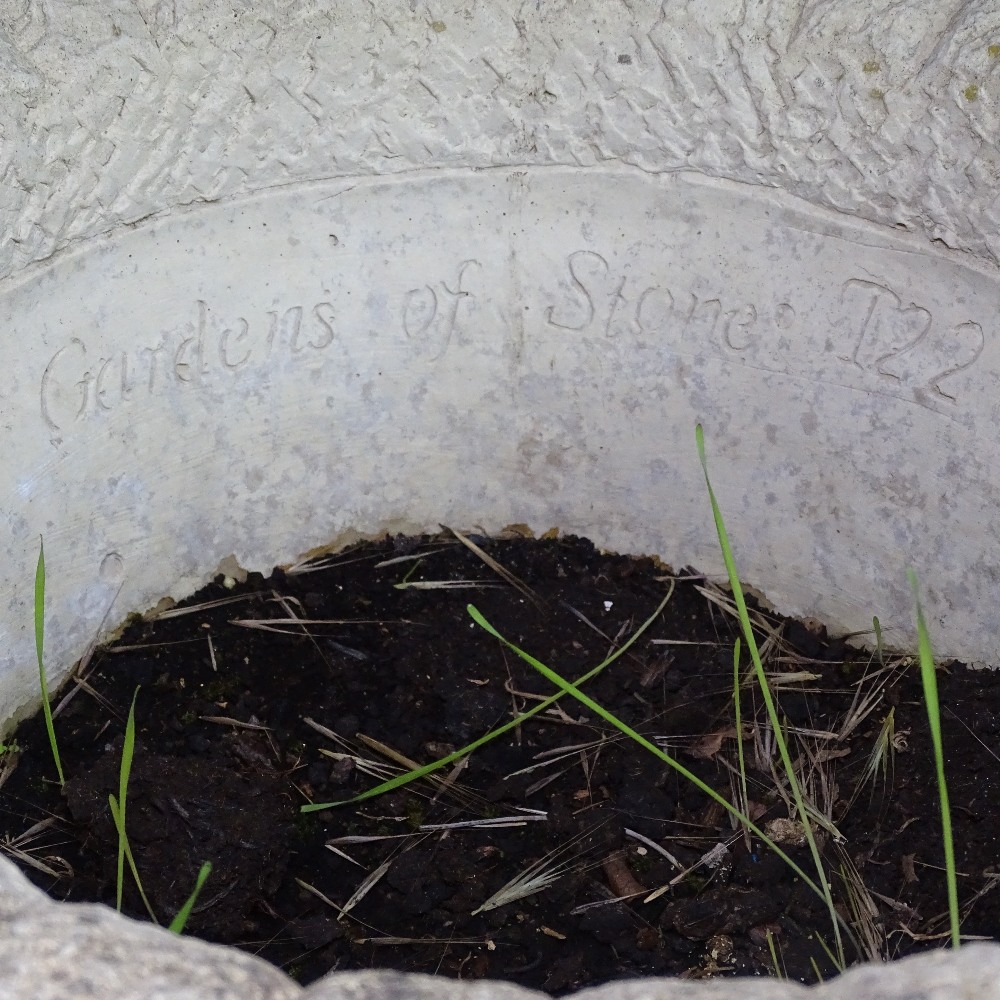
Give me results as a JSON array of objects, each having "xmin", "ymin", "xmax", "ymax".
[{"xmin": 2, "ymin": 167, "xmax": 1000, "ymax": 732}]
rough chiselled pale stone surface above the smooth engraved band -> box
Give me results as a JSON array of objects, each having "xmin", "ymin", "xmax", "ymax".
[{"xmin": 0, "ymin": 0, "xmax": 1000, "ymax": 272}]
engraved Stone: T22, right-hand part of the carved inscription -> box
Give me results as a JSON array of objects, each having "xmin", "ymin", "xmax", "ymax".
[{"xmin": 543, "ymin": 250, "xmax": 986, "ymax": 414}]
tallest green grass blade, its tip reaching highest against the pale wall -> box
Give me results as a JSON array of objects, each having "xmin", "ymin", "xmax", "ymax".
[{"xmin": 695, "ymin": 424, "xmax": 846, "ymax": 969}]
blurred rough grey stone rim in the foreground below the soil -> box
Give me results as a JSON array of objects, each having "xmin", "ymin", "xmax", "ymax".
[{"xmin": 0, "ymin": 858, "xmax": 1000, "ymax": 1000}]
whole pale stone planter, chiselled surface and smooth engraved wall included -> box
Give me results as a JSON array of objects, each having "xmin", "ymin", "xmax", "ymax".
[{"xmin": 0, "ymin": 0, "xmax": 1000, "ymax": 997}]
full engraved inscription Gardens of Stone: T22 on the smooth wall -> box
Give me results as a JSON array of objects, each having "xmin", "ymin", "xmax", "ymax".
[{"xmin": 35, "ymin": 232, "xmax": 986, "ymax": 433}]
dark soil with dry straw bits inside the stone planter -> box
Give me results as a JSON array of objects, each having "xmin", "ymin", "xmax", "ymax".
[{"xmin": 0, "ymin": 536, "xmax": 1000, "ymax": 994}]
